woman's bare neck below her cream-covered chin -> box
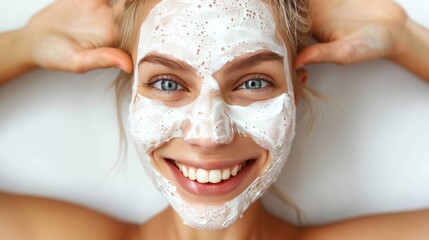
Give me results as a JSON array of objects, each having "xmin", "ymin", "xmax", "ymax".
[{"xmin": 138, "ymin": 200, "xmax": 296, "ymax": 240}]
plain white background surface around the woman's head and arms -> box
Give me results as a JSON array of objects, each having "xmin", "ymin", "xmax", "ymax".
[{"xmin": 0, "ymin": 0, "xmax": 429, "ymax": 224}]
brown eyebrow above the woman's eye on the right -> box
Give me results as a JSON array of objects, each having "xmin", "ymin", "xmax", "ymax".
[{"xmin": 225, "ymin": 51, "xmax": 284, "ymax": 73}]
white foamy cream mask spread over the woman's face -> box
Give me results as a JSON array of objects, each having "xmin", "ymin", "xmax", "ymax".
[{"xmin": 129, "ymin": 0, "xmax": 295, "ymax": 229}]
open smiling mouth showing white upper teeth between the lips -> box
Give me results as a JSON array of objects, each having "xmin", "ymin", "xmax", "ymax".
[{"xmin": 167, "ymin": 159, "xmax": 256, "ymax": 184}]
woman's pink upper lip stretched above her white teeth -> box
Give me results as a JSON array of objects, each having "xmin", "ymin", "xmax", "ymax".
[{"xmin": 164, "ymin": 158, "xmax": 257, "ymax": 170}]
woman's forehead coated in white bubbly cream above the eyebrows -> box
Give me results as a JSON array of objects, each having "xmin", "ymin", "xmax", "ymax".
[{"xmin": 137, "ymin": 0, "xmax": 286, "ymax": 75}]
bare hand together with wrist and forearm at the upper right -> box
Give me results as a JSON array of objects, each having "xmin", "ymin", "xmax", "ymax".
[{"xmin": 295, "ymin": 0, "xmax": 429, "ymax": 82}]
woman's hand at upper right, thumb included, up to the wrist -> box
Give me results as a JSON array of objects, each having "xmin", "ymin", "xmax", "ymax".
[{"xmin": 295, "ymin": 0, "xmax": 408, "ymax": 68}]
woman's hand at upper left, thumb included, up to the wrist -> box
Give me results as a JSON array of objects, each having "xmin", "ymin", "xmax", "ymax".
[{"xmin": 22, "ymin": 0, "xmax": 133, "ymax": 72}]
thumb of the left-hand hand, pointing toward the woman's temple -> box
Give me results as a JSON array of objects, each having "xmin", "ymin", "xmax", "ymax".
[{"xmin": 71, "ymin": 48, "xmax": 133, "ymax": 73}]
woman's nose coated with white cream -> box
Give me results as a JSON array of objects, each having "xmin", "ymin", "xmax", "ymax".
[{"xmin": 185, "ymin": 97, "xmax": 235, "ymax": 149}]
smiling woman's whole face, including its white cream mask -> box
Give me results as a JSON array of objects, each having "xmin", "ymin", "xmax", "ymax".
[{"xmin": 130, "ymin": 0, "xmax": 295, "ymax": 228}]
